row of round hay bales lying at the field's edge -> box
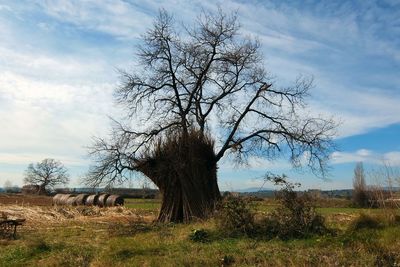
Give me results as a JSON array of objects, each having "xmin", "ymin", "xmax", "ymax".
[{"xmin": 53, "ymin": 194, "xmax": 124, "ymax": 207}]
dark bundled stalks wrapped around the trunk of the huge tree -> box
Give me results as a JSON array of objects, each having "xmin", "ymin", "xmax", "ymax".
[{"xmin": 138, "ymin": 133, "xmax": 220, "ymax": 222}]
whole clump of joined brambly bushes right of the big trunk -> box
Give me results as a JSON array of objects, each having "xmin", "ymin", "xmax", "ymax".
[{"xmin": 216, "ymin": 176, "xmax": 332, "ymax": 239}]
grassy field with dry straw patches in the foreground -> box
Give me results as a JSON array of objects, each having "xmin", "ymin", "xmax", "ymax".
[{"xmin": 0, "ymin": 195, "xmax": 400, "ymax": 266}]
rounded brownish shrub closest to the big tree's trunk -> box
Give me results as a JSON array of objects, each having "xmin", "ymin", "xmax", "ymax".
[{"xmin": 216, "ymin": 195, "xmax": 255, "ymax": 236}]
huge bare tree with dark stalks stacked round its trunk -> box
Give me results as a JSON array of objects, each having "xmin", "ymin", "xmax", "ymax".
[{"xmin": 87, "ymin": 11, "xmax": 335, "ymax": 221}]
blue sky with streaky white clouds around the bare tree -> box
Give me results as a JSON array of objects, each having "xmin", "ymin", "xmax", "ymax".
[{"xmin": 0, "ymin": 0, "xmax": 400, "ymax": 190}]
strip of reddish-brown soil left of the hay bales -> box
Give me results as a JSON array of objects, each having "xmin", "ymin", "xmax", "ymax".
[{"xmin": 0, "ymin": 194, "xmax": 52, "ymax": 206}]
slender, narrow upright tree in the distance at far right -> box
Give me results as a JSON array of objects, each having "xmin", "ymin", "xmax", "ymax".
[{"xmin": 353, "ymin": 162, "xmax": 368, "ymax": 207}]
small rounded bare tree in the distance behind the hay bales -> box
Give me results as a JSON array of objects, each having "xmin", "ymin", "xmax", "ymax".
[{"xmin": 24, "ymin": 159, "xmax": 69, "ymax": 194}]
